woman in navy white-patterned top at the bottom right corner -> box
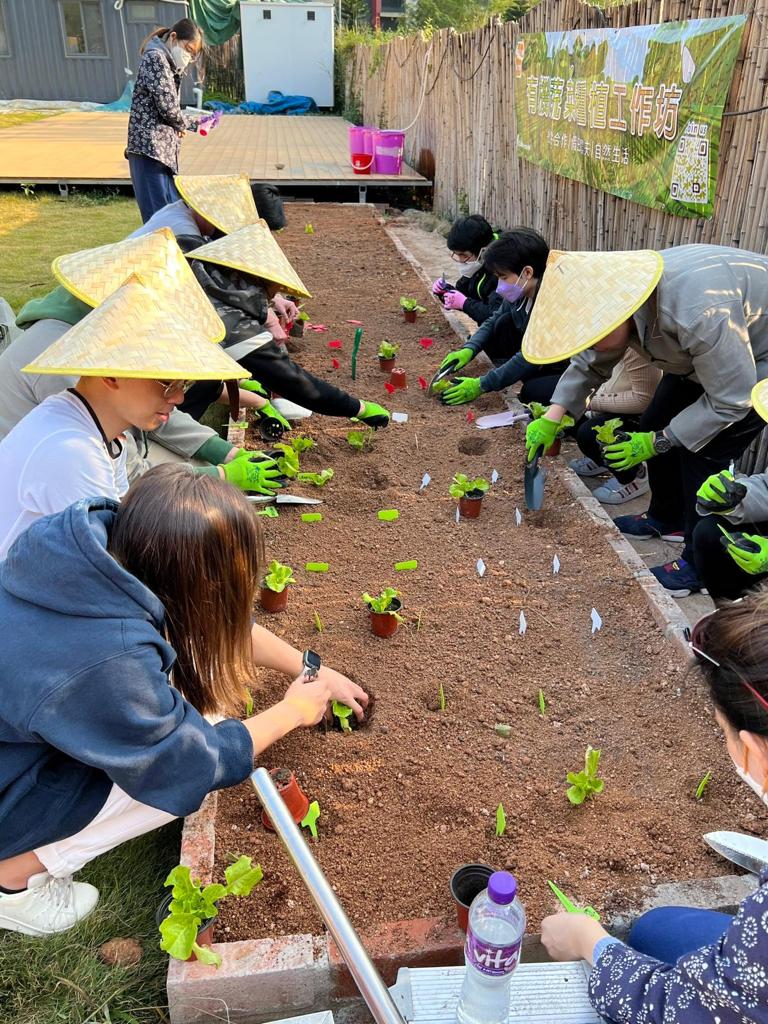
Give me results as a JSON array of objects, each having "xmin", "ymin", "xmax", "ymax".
[{"xmin": 542, "ymin": 592, "xmax": 768, "ymax": 1024}]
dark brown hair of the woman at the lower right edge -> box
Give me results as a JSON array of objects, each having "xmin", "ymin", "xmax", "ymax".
[{"xmin": 691, "ymin": 589, "xmax": 768, "ymax": 739}]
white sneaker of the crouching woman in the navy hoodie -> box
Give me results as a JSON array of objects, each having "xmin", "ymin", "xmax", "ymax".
[{"xmin": 0, "ymin": 871, "xmax": 98, "ymax": 936}]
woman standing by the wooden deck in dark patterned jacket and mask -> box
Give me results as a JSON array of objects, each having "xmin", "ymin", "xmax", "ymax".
[{"xmin": 125, "ymin": 17, "xmax": 203, "ymax": 223}]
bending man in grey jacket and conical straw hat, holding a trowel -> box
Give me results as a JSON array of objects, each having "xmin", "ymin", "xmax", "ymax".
[{"xmin": 522, "ymin": 245, "xmax": 768, "ymax": 597}]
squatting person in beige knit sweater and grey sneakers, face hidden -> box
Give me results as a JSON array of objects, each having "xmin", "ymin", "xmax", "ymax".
[{"xmin": 569, "ymin": 348, "xmax": 662, "ymax": 505}]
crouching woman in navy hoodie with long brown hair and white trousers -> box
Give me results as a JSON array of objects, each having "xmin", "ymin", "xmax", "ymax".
[{"xmin": 0, "ymin": 464, "xmax": 368, "ymax": 936}]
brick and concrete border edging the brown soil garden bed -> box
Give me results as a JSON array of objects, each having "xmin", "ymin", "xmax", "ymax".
[{"xmin": 167, "ymin": 224, "xmax": 756, "ymax": 1024}]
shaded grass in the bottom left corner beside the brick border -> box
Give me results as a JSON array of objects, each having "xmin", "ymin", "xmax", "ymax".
[{"xmin": 0, "ymin": 823, "xmax": 179, "ymax": 1024}]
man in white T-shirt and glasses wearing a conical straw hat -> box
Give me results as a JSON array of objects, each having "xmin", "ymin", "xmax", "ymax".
[{"xmin": 0, "ymin": 275, "xmax": 280, "ymax": 558}]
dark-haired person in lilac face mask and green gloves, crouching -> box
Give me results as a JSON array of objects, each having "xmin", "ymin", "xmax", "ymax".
[{"xmin": 440, "ymin": 227, "xmax": 567, "ymax": 406}]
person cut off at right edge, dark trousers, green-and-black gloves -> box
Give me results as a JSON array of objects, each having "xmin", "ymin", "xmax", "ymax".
[{"xmin": 693, "ymin": 379, "xmax": 768, "ymax": 604}]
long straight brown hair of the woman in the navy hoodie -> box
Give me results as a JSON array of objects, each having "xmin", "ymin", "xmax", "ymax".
[{"xmin": 110, "ymin": 463, "xmax": 264, "ymax": 714}]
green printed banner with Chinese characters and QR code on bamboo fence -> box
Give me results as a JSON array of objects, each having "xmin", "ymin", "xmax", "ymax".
[{"xmin": 514, "ymin": 15, "xmax": 746, "ymax": 217}]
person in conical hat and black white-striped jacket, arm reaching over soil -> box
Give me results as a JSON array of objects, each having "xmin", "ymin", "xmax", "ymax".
[{"xmin": 182, "ymin": 223, "xmax": 389, "ymax": 429}]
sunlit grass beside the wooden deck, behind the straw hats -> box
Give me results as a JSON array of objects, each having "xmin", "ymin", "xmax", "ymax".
[{"xmin": 0, "ymin": 190, "xmax": 141, "ymax": 312}]
